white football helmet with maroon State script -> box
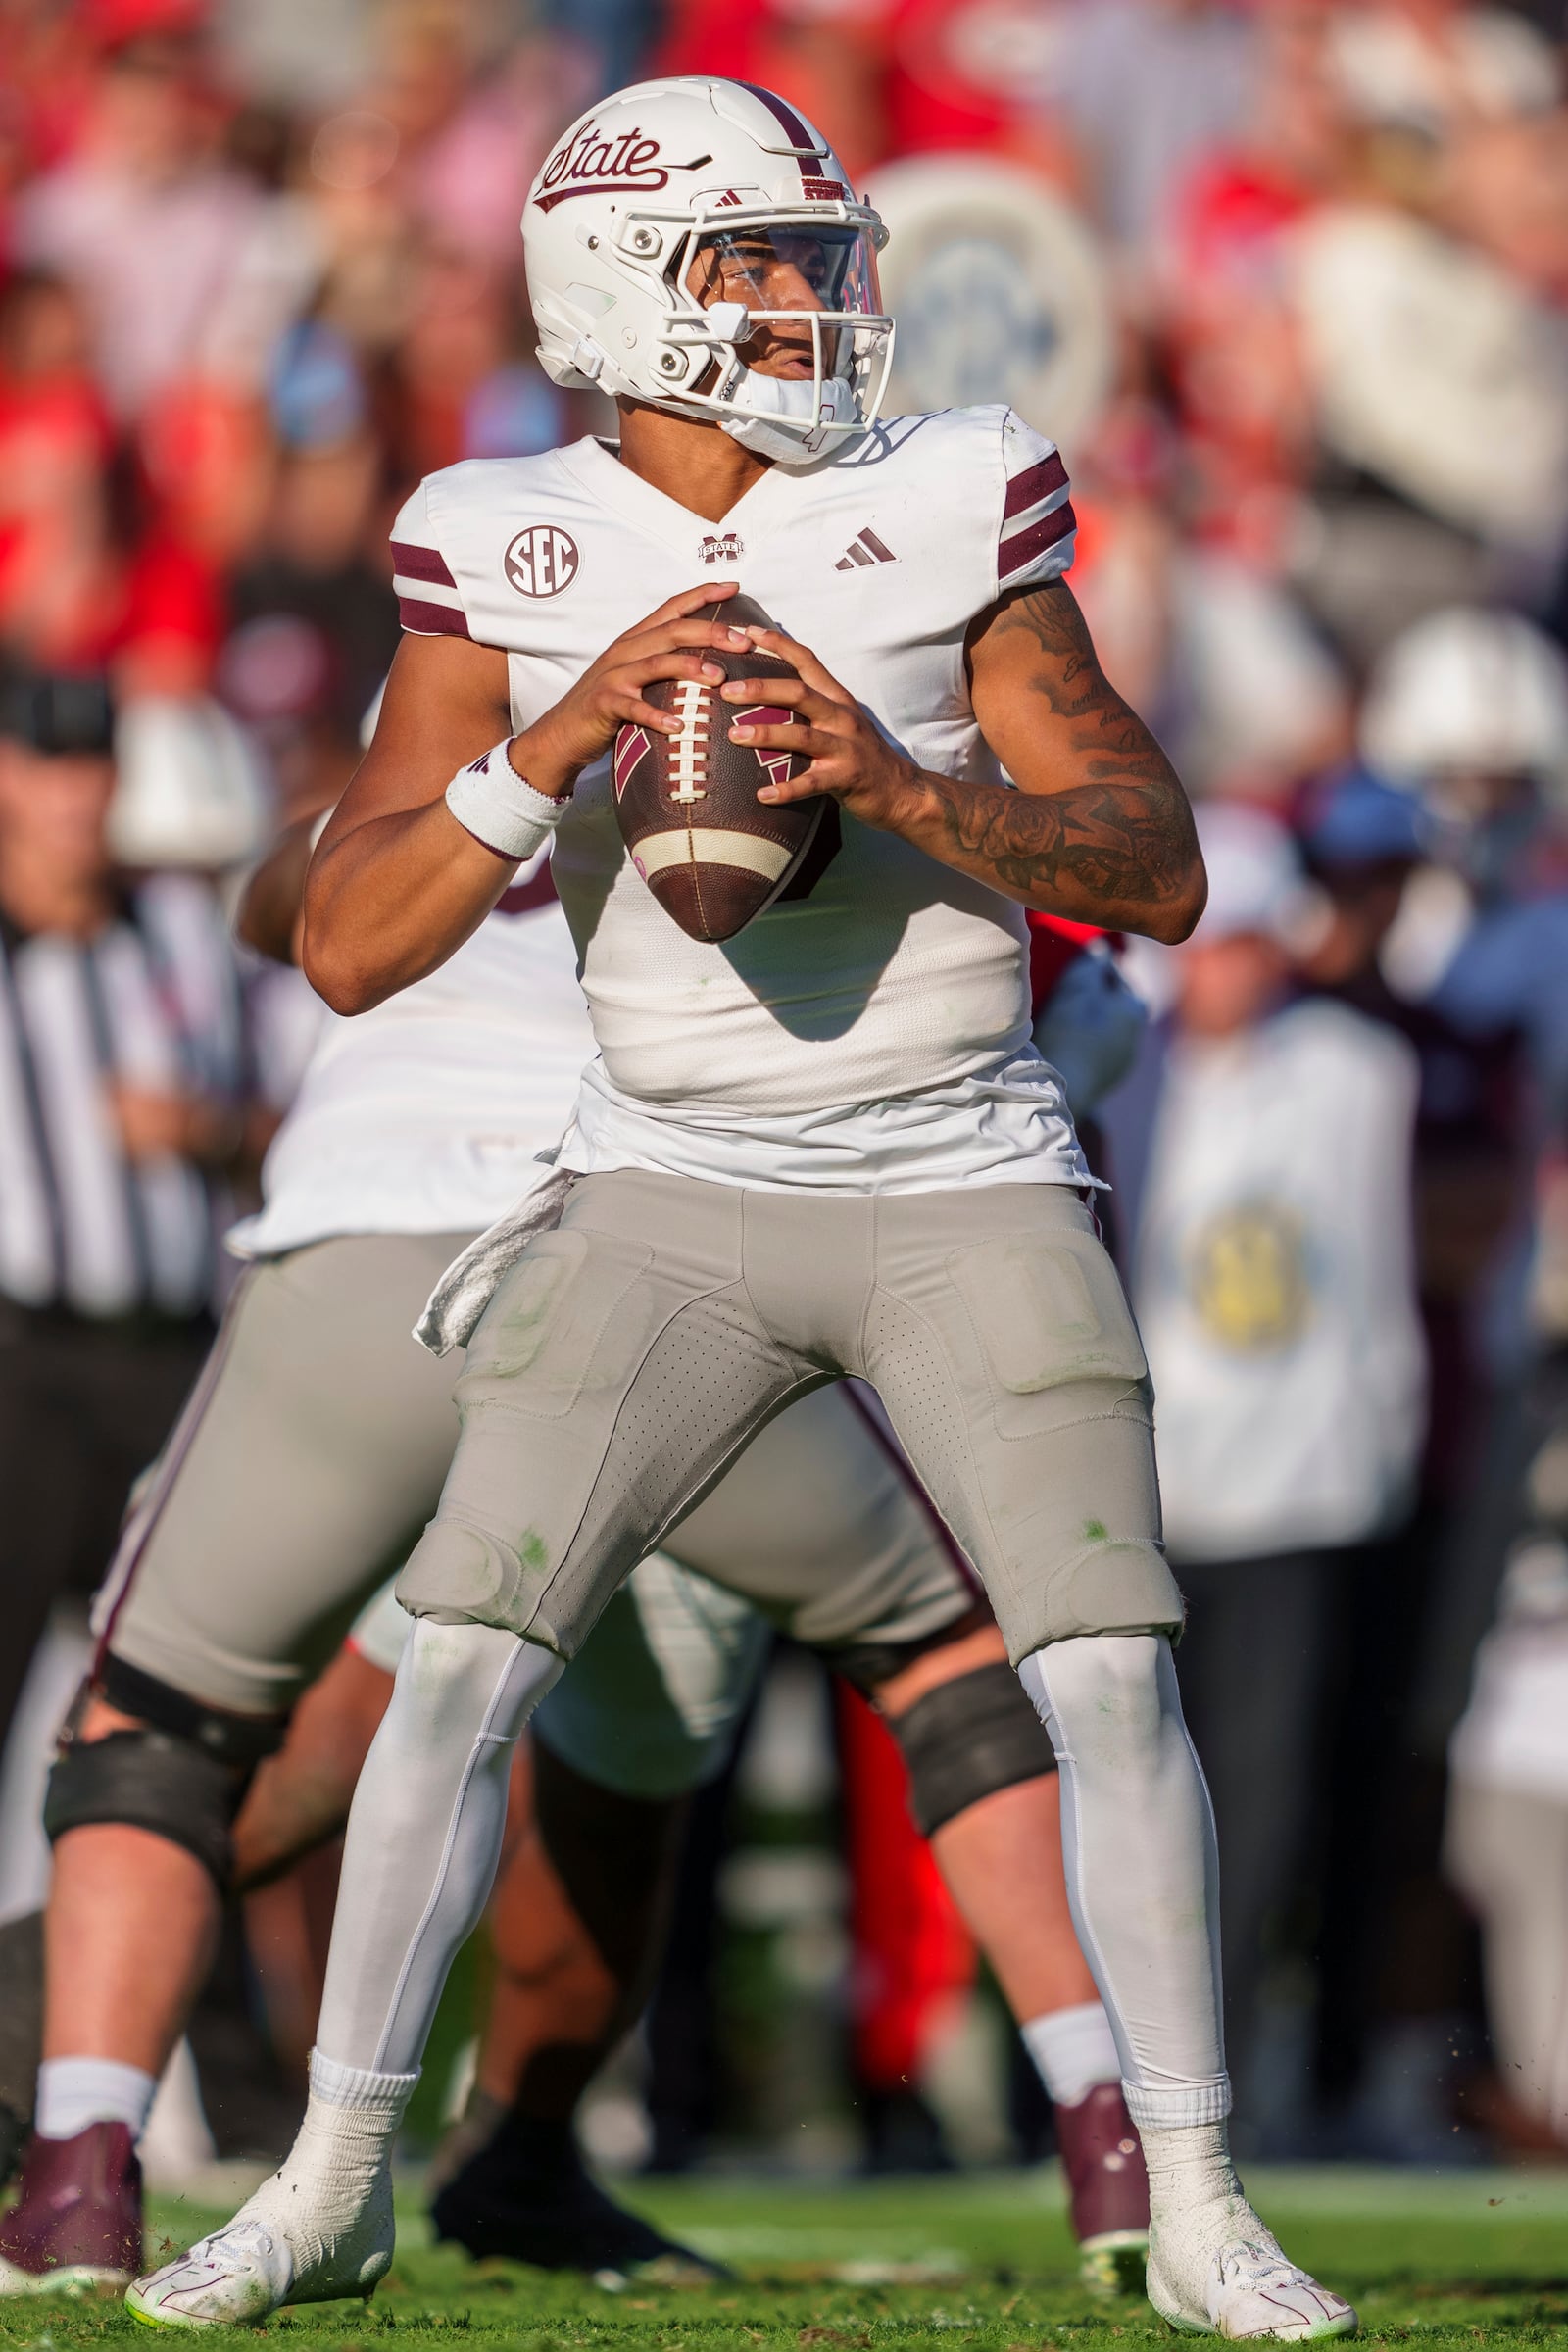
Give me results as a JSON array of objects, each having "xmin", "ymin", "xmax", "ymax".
[{"xmin": 522, "ymin": 75, "xmax": 894, "ymax": 466}]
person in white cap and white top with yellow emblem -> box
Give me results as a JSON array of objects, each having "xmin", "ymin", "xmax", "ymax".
[{"xmin": 1102, "ymin": 802, "xmax": 1425, "ymax": 2112}]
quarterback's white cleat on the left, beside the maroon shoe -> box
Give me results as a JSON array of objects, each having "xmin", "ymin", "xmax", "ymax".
[{"xmin": 124, "ymin": 2174, "xmax": 395, "ymax": 2328}]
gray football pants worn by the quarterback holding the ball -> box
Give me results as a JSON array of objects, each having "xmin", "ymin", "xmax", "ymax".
[{"xmin": 397, "ymin": 1174, "xmax": 1183, "ymax": 1663}]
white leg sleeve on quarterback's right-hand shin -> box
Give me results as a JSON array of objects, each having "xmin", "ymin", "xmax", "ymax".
[{"xmin": 1020, "ymin": 1635, "xmax": 1230, "ymax": 2129}]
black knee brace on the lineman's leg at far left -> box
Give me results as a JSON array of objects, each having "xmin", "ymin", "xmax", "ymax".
[{"xmin": 45, "ymin": 1656, "xmax": 287, "ymax": 1891}]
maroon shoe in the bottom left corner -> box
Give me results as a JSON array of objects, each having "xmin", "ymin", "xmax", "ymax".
[{"xmin": 0, "ymin": 2124, "xmax": 141, "ymax": 2295}]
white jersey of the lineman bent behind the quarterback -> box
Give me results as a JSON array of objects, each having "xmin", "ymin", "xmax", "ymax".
[{"xmin": 228, "ymin": 852, "xmax": 592, "ymax": 1258}]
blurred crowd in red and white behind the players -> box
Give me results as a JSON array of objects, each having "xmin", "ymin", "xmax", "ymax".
[{"xmin": 0, "ymin": 0, "xmax": 1568, "ymax": 2162}]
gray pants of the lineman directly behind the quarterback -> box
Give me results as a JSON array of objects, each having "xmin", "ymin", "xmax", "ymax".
[{"xmin": 94, "ymin": 1235, "xmax": 973, "ymax": 1721}]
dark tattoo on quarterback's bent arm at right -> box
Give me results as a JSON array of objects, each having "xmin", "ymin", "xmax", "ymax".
[{"xmin": 926, "ymin": 581, "xmax": 1199, "ymax": 922}]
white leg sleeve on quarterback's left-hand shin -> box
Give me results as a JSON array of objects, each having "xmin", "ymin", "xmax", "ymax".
[{"xmin": 318, "ymin": 1621, "xmax": 562, "ymax": 2075}]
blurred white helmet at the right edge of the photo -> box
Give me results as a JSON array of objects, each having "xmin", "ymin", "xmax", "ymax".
[{"xmin": 1361, "ymin": 605, "xmax": 1568, "ymax": 800}]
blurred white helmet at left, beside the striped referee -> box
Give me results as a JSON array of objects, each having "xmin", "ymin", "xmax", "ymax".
[{"xmin": 108, "ymin": 694, "xmax": 272, "ymax": 872}]
